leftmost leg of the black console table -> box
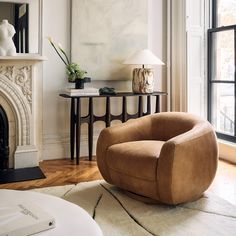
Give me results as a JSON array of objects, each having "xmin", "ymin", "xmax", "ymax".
[{"xmin": 70, "ymin": 98, "xmax": 75, "ymax": 160}]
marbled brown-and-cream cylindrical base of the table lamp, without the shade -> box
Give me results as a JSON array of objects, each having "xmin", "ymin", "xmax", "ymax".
[{"xmin": 132, "ymin": 68, "xmax": 154, "ymax": 93}]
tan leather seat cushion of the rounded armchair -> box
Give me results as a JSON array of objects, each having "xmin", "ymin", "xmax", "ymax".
[{"xmin": 107, "ymin": 140, "xmax": 165, "ymax": 181}]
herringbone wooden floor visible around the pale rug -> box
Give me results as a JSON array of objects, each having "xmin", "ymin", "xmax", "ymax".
[{"xmin": 0, "ymin": 159, "xmax": 236, "ymax": 205}]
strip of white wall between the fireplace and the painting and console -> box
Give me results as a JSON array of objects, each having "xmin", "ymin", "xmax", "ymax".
[{"xmin": 43, "ymin": 0, "xmax": 70, "ymax": 159}]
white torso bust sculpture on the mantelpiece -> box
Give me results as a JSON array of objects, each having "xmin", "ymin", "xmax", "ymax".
[{"xmin": 0, "ymin": 20, "xmax": 16, "ymax": 56}]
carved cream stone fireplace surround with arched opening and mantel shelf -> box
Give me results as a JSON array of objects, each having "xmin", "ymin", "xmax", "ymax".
[{"xmin": 0, "ymin": 55, "xmax": 44, "ymax": 169}]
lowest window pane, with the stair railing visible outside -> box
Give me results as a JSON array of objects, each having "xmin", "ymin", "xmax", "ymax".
[{"xmin": 211, "ymin": 83, "xmax": 235, "ymax": 135}]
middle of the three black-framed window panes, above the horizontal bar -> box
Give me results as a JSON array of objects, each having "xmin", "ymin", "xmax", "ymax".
[{"xmin": 211, "ymin": 29, "xmax": 236, "ymax": 80}]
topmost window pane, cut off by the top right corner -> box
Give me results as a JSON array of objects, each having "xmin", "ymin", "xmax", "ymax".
[{"xmin": 217, "ymin": 0, "xmax": 236, "ymax": 27}]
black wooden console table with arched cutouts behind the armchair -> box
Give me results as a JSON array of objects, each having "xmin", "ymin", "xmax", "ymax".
[{"xmin": 60, "ymin": 92, "xmax": 167, "ymax": 164}]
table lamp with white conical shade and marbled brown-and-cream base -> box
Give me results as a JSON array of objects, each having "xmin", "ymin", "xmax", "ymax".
[{"xmin": 123, "ymin": 49, "xmax": 164, "ymax": 93}]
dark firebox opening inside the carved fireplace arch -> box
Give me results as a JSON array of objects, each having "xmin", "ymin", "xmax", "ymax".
[{"xmin": 0, "ymin": 105, "xmax": 9, "ymax": 170}]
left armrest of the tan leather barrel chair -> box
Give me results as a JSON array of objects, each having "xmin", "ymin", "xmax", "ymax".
[{"xmin": 96, "ymin": 117, "xmax": 152, "ymax": 183}]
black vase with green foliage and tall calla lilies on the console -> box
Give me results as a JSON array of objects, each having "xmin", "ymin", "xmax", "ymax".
[{"xmin": 48, "ymin": 37, "xmax": 91, "ymax": 85}]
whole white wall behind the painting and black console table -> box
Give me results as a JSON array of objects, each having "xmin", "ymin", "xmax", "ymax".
[{"xmin": 43, "ymin": 0, "xmax": 166, "ymax": 160}]
